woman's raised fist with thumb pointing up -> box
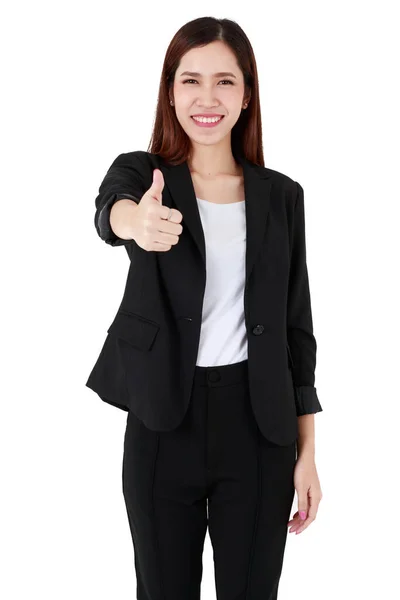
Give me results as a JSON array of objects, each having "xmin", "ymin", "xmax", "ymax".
[{"xmin": 132, "ymin": 169, "xmax": 183, "ymax": 252}]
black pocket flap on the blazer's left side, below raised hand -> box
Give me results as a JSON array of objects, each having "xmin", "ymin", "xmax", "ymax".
[{"xmin": 107, "ymin": 310, "xmax": 160, "ymax": 350}]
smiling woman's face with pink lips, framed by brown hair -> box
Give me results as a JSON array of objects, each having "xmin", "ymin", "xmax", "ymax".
[{"xmin": 172, "ymin": 41, "xmax": 247, "ymax": 144}]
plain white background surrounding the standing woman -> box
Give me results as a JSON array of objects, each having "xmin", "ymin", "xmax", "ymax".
[{"xmin": 0, "ymin": 0, "xmax": 400, "ymax": 600}]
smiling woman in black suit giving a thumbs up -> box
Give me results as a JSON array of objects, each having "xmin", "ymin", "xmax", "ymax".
[{"xmin": 86, "ymin": 17, "xmax": 322, "ymax": 600}]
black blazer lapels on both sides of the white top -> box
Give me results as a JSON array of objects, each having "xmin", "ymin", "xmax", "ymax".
[{"xmin": 159, "ymin": 157, "xmax": 272, "ymax": 284}]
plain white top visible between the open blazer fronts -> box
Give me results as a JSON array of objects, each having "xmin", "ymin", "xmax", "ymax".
[{"xmin": 196, "ymin": 198, "xmax": 247, "ymax": 367}]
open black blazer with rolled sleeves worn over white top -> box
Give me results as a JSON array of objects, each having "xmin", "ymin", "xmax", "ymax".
[{"xmin": 86, "ymin": 150, "xmax": 322, "ymax": 445}]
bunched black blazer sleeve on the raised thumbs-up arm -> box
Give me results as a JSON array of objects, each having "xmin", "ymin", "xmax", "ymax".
[{"xmin": 94, "ymin": 151, "xmax": 146, "ymax": 246}]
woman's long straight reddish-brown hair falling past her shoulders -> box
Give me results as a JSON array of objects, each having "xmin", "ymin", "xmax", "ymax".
[{"xmin": 147, "ymin": 17, "xmax": 265, "ymax": 167}]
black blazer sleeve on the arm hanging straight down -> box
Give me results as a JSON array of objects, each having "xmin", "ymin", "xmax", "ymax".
[{"xmin": 287, "ymin": 182, "xmax": 322, "ymax": 416}]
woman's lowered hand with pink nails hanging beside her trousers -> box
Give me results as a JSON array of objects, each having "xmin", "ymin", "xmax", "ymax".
[{"xmin": 288, "ymin": 454, "xmax": 322, "ymax": 535}]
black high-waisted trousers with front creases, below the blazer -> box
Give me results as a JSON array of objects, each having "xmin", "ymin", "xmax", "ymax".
[{"xmin": 122, "ymin": 361, "xmax": 297, "ymax": 600}]
